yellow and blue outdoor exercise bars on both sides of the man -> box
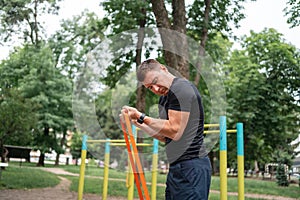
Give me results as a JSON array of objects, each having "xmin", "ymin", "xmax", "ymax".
[{"xmin": 78, "ymin": 116, "xmax": 245, "ymax": 200}]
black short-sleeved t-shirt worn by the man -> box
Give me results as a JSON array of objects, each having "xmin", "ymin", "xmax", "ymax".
[{"xmin": 159, "ymin": 78, "xmax": 207, "ymax": 164}]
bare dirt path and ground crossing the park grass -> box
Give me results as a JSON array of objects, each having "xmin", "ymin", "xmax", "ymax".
[{"xmin": 0, "ymin": 168, "xmax": 299, "ymax": 200}]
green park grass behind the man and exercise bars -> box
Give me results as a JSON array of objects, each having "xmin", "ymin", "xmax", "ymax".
[{"xmin": 0, "ymin": 163, "xmax": 300, "ymax": 200}]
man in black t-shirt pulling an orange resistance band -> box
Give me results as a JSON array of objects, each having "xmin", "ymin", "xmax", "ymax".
[{"xmin": 122, "ymin": 59, "xmax": 211, "ymax": 200}]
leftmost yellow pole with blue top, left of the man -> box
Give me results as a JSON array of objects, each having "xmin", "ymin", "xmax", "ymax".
[{"xmin": 78, "ymin": 135, "xmax": 87, "ymax": 200}]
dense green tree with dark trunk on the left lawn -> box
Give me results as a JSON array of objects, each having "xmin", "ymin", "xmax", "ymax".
[{"xmin": 21, "ymin": 46, "xmax": 72, "ymax": 166}]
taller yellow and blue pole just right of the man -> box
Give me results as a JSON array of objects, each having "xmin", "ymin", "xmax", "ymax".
[{"xmin": 220, "ymin": 116, "xmax": 227, "ymax": 200}]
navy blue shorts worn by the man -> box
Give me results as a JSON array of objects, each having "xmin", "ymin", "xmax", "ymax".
[{"xmin": 166, "ymin": 157, "xmax": 212, "ymax": 200}]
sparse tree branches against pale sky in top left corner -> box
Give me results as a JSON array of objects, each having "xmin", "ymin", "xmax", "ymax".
[{"xmin": 0, "ymin": 0, "xmax": 60, "ymax": 45}]
